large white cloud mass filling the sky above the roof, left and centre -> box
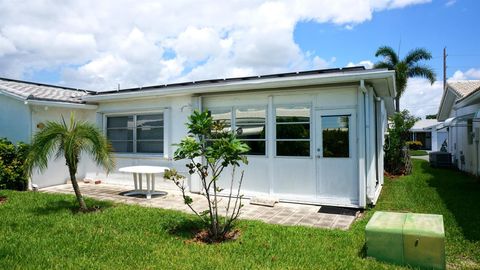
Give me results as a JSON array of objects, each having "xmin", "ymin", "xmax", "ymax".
[{"xmin": 0, "ymin": 0, "xmax": 430, "ymax": 90}]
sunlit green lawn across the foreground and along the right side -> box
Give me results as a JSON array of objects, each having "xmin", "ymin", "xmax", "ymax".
[{"xmin": 0, "ymin": 160, "xmax": 480, "ymax": 269}]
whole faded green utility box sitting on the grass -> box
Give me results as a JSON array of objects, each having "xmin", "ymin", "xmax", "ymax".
[{"xmin": 365, "ymin": 211, "xmax": 445, "ymax": 269}]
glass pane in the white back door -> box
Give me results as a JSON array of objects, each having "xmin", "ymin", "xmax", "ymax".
[{"xmin": 322, "ymin": 115, "xmax": 350, "ymax": 158}]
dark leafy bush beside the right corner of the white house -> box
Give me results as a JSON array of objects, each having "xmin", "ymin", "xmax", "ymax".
[{"xmin": 385, "ymin": 110, "xmax": 418, "ymax": 175}]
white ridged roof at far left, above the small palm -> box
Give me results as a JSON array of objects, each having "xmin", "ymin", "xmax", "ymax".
[{"xmin": 0, "ymin": 78, "xmax": 93, "ymax": 103}]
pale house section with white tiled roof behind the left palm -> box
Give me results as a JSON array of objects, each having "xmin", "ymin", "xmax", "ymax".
[{"xmin": 0, "ymin": 78, "xmax": 97, "ymax": 187}]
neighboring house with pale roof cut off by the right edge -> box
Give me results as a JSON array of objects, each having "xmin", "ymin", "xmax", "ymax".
[{"xmin": 438, "ymin": 80, "xmax": 480, "ymax": 175}]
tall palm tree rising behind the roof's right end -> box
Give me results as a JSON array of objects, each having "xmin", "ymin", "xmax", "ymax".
[{"xmin": 375, "ymin": 46, "xmax": 436, "ymax": 112}]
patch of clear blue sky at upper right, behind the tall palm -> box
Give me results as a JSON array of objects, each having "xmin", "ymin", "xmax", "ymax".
[{"xmin": 294, "ymin": 0, "xmax": 480, "ymax": 78}]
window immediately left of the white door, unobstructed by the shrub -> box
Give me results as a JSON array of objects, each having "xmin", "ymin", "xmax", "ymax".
[{"xmin": 275, "ymin": 106, "xmax": 310, "ymax": 156}]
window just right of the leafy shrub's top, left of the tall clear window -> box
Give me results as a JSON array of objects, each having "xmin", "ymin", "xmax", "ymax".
[{"xmin": 235, "ymin": 107, "xmax": 267, "ymax": 155}]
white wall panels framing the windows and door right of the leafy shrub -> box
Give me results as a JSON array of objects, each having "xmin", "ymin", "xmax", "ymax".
[{"xmin": 202, "ymin": 86, "xmax": 359, "ymax": 206}]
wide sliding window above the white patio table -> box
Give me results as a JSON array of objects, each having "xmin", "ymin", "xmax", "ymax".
[{"xmin": 107, "ymin": 113, "xmax": 164, "ymax": 153}]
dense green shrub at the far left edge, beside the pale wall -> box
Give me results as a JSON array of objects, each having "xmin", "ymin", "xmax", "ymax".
[{"xmin": 0, "ymin": 139, "xmax": 29, "ymax": 190}]
